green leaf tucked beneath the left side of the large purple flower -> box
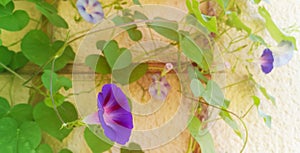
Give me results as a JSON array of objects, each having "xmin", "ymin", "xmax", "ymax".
[{"xmin": 84, "ymin": 128, "xmax": 113, "ymax": 153}]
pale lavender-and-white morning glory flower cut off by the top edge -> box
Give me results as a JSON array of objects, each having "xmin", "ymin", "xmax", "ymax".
[{"xmin": 76, "ymin": 0, "xmax": 104, "ymax": 23}]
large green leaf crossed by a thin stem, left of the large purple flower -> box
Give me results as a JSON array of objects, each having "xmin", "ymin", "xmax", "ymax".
[{"xmin": 33, "ymin": 102, "xmax": 77, "ymax": 141}]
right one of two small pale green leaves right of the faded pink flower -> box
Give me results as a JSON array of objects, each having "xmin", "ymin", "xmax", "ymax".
[{"xmin": 203, "ymin": 80, "xmax": 224, "ymax": 107}]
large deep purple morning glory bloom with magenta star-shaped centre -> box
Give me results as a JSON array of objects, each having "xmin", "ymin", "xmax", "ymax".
[{"xmin": 83, "ymin": 84, "xmax": 133, "ymax": 145}]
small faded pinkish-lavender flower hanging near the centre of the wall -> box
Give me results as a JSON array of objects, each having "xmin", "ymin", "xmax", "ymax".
[{"xmin": 149, "ymin": 74, "xmax": 171, "ymax": 100}]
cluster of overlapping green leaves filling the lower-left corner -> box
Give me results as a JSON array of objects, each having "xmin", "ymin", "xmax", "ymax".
[{"xmin": 0, "ymin": 97, "xmax": 77, "ymax": 153}]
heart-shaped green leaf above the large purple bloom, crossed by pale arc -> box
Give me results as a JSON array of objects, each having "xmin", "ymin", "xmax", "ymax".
[{"xmin": 103, "ymin": 40, "xmax": 132, "ymax": 69}]
